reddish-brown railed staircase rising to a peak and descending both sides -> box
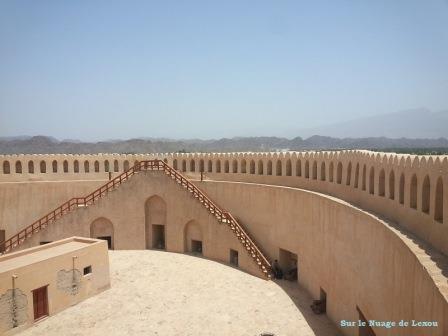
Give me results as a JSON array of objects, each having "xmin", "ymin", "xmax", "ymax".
[{"xmin": 0, "ymin": 160, "xmax": 272, "ymax": 278}]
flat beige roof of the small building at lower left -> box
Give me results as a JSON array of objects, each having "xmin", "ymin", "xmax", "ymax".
[{"xmin": 0, "ymin": 238, "xmax": 97, "ymax": 273}]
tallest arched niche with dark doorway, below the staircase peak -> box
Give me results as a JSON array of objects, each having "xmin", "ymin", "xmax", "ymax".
[{"xmin": 145, "ymin": 196, "xmax": 166, "ymax": 250}]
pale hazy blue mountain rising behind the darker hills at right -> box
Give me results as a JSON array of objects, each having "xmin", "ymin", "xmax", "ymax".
[{"xmin": 297, "ymin": 109, "xmax": 448, "ymax": 139}]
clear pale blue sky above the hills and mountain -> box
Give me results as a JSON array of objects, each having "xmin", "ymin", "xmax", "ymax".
[{"xmin": 0, "ymin": 0, "xmax": 448, "ymax": 141}]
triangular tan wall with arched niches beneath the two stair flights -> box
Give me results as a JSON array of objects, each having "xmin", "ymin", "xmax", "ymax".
[{"xmin": 11, "ymin": 172, "xmax": 263, "ymax": 277}]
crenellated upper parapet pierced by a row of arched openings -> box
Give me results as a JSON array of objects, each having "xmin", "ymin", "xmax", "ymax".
[{"xmin": 0, "ymin": 150, "xmax": 448, "ymax": 255}]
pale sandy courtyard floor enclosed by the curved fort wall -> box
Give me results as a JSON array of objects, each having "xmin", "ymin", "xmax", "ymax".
[{"xmin": 20, "ymin": 250, "xmax": 339, "ymax": 336}]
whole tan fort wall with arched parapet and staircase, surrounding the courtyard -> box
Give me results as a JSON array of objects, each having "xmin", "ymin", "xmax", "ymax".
[{"xmin": 0, "ymin": 150, "xmax": 448, "ymax": 335}]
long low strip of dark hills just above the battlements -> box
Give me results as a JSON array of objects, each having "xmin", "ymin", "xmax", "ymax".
[{"xmin": 0, "ymin": 135, "xmax": 448, "ymax": 154}]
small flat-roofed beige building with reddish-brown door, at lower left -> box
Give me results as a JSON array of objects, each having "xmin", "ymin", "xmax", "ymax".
[{"xmin": 0, "ymin": 237, "xmax": 110, "ymax": 336}]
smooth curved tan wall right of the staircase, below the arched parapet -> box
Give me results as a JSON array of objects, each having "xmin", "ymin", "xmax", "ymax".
[{"xmin": 198, "ymin": 181, "xmax": 448, "ymax": 336}]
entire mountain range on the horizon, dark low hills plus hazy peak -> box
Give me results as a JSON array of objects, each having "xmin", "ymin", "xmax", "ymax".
[{"xmin": 0, "ymin": 109, "xmax": 448, "ymax": 154}]
